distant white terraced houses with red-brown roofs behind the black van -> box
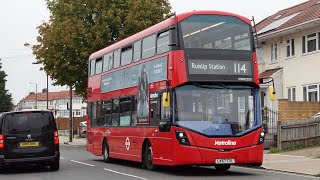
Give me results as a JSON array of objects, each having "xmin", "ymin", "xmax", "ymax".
[{"xmin": 16, "ymin": 90, "xmax": 87, "ymax": 118}]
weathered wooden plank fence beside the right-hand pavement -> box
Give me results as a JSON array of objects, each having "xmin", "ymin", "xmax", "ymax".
[{"xmin": 277, "ymin": 120, "xmax": 320, "ymax": 149}]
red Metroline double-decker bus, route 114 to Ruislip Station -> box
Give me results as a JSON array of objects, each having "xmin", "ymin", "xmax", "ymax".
[{"xmin": 87, "ymin": 11, "xmax": 264, "ymax": 170}]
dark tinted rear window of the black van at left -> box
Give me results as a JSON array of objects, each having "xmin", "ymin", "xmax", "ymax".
[{"xmin": 3, "ymin": 112, "xmax": 53, "ymax": 134}]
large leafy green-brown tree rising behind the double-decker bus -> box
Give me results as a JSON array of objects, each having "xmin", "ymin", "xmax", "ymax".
[{"xmin": 32, "ymin": 0, "xmax": 171, "ymax": 97}]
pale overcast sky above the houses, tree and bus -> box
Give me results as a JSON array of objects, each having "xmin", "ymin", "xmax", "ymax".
[{"xmin": 0, "ymin": 0, "xmax": 306, "ymax": 104}]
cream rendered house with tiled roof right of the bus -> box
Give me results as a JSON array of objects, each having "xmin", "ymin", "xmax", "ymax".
[{"xmin": 256, "ymin": 0, "xmax": 320, "ymax": 109}]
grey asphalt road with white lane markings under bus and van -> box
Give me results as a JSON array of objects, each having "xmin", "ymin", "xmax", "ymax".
[{"xmin": 0, "ymin": 145, "xmax": 320, "ymax": 180}]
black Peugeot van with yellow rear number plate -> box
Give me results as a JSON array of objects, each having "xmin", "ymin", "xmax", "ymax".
[{"xmin": 0, "ymin": 110, "xmax": 60, "ymax": 171}]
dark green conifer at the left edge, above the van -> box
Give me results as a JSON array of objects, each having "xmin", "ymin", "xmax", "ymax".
[{"xmin": 0, "ymin": 59, "xmax": 13, "ymax": 112}]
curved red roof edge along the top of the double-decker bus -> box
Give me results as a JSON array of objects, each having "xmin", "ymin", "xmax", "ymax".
[{"xmin": 89, "ymin": 10, "xmax": 251, "ymax": 60}]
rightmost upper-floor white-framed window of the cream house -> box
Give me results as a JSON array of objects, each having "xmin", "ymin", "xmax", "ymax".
[{"xmin": 302, "ymin": 33, "xmax": 319, "ymax": 53}]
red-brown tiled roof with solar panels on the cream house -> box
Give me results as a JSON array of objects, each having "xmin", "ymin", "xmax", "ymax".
[{"xmin": 256, "ymin": 0, "xmax": 320, "ymax": 35}]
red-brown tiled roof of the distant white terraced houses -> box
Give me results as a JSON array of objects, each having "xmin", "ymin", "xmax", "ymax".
[{"xmin": 20, "ymin": 90, "xmax": 81, "ymax": 102}]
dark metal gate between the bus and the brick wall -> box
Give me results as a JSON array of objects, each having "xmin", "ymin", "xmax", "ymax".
[{"xmin": 261, "ymin": 107, "xmax": 278, "ymax": 149}]
